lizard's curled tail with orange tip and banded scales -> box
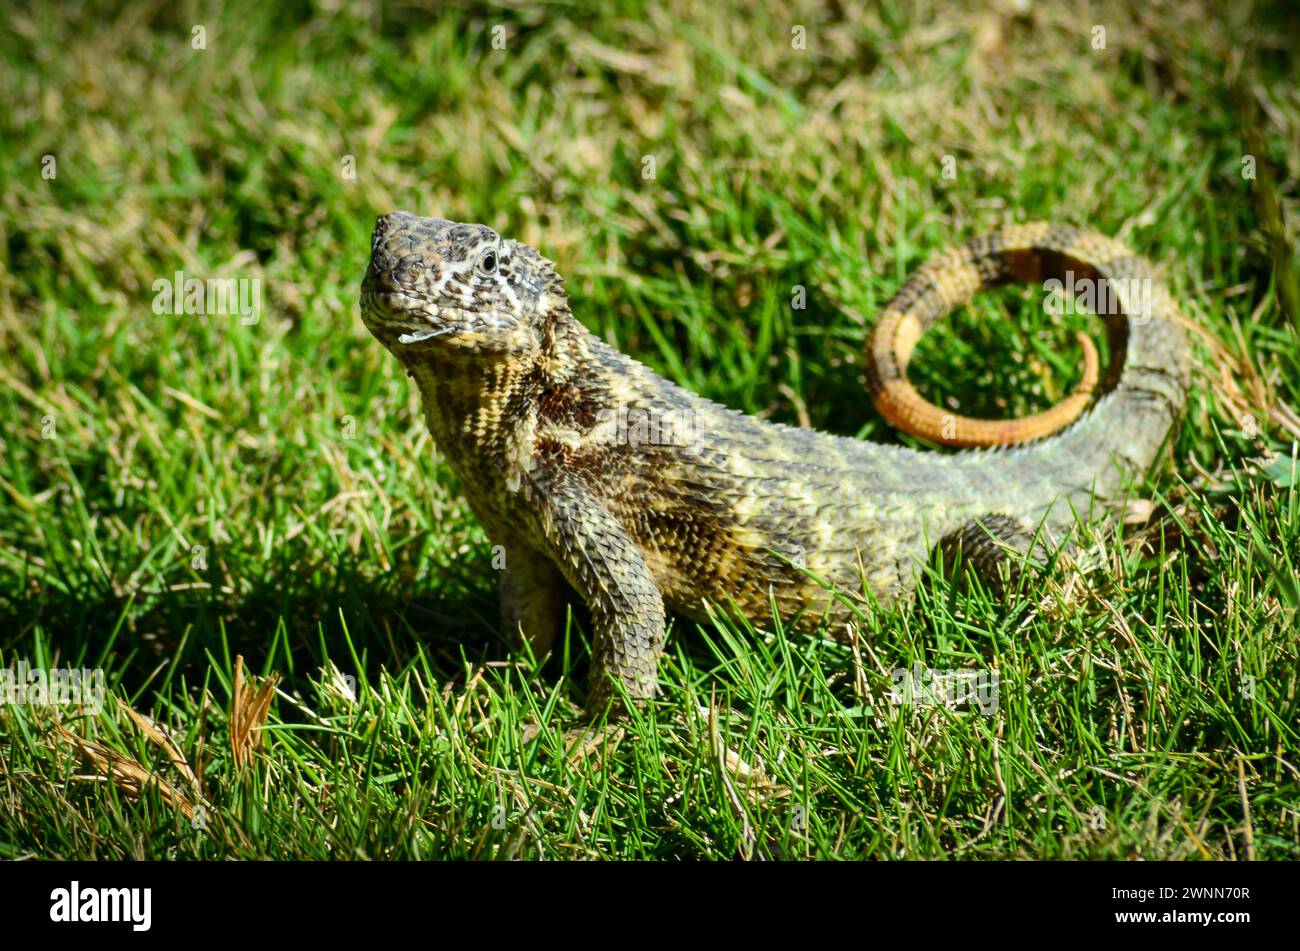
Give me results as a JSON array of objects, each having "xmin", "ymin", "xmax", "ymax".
[{"xmin": 867, "ymin": 222, "xmax": 1190, "ymax": 466}]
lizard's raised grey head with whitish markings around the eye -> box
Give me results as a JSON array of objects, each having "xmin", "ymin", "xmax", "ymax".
[{"xmin": 361, "ymin": 212, "xmax": 566, "ymax": 362}]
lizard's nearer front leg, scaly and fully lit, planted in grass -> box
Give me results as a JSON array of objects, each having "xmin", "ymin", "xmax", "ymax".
[{"xmin": 529, "ymin": 466, "xmax": 664, "ymax": 716}]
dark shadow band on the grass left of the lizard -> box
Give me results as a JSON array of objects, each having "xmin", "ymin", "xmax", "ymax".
[{"xmin": 0, "ymin": 556, "xmax": 510, "ymax": 692}]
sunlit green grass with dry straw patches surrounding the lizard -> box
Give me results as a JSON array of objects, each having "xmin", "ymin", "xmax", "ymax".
[{"xmin": 0, "ymin": 0, "xmax": 1300, "ymax": 859}]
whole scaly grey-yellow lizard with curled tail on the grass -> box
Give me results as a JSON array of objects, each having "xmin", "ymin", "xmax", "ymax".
[{"xmin": 361, "ymin": 212, "xmax": 1188, "ymax": 712}]
